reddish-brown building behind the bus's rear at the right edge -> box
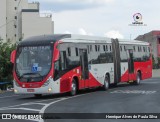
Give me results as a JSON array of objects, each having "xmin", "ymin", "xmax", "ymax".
[{"xmin": 136, "ymin": 31, "xmax": 160, "ymax": 63}]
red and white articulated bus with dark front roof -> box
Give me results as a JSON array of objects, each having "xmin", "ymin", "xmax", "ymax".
[{"xmin": 11, "ymin": 34, "xmax": 152, "ymax": 96}]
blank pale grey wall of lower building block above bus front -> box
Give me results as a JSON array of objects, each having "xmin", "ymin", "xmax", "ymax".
[{"xmin": 22, "ymin": 12, "xmax": 53, "ymax": 39}]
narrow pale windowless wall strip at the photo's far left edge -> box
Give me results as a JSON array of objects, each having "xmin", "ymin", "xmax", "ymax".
[{"xmin": 0, "ymin": 0, "xmax": 6, "ymax": 41}]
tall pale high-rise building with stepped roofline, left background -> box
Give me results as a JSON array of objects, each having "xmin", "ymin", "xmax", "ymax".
[{"xmin": 0, "ymin": 0, "xmax": 54, "ymax": 43}]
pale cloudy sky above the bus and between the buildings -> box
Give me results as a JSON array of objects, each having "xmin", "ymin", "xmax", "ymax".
[{"xmin": 28, "ymin": 0, "xmax": 160, "ymax": 39}]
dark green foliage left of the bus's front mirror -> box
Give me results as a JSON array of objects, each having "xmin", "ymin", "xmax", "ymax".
[{"xmin": 0, "ymin": 41, "xmax": 16, "ymax": 81}]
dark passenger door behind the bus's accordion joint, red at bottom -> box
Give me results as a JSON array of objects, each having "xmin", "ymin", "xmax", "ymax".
[{"xmin": 127, "ymin": 49, "xmax": 134, "ymax": 81}]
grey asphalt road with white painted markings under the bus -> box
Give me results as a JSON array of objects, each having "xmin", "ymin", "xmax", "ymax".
[{"xmin": 0, "ymin": 78, "xmax": 160, "ymax": 122}]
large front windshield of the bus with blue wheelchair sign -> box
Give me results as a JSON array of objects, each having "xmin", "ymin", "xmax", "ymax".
[{"xmin": 15, "ymin": 46, "xmax": 52, "ymax": 82}]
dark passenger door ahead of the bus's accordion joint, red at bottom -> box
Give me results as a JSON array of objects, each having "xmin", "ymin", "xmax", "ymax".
[{"xmin": 79, "ymin": 49, "xmax": 89, "ymax": 88}]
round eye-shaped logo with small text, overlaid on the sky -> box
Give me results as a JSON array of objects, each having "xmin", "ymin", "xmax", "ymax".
[{"xmin": 129, "ymin": 13, "xmax": 147, "ymax": 26}]
